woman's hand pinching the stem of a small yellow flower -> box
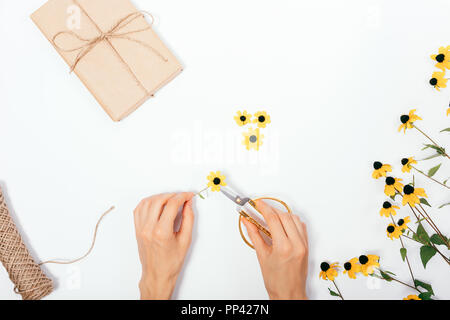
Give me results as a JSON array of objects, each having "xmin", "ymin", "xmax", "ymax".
[{"xmin": 134, "ymin": 193, "xmax": 194, "ymax": 300}]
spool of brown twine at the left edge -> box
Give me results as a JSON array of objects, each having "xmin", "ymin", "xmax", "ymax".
[{"xmin": 0, "ymin": 189, "xmax": 53, "ymax": 300}]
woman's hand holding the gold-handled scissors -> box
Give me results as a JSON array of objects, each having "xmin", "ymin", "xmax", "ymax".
[{"xmin": 243, "ymin": 201, "xmax": 308, "ymax": 300}]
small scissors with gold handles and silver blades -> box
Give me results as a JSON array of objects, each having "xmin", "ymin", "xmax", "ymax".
[{"xmin": 220, "ymin": 187, "xmax": 292, "ymax": 249}]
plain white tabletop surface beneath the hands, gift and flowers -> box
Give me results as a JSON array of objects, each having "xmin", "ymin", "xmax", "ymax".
[{"xmin": 0, "ymin": 0, "xmax": 450, "ymax": 299}]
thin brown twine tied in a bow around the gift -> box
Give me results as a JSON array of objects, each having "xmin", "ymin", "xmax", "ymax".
[{"xmin": 52, "ymin": 0, "xmax": 169, "ymax": 95}]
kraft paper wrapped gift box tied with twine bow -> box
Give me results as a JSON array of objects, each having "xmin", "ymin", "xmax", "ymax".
[{"xmin": 31, "ymin": 0, "xmax": 182, "ymax": 121}]
